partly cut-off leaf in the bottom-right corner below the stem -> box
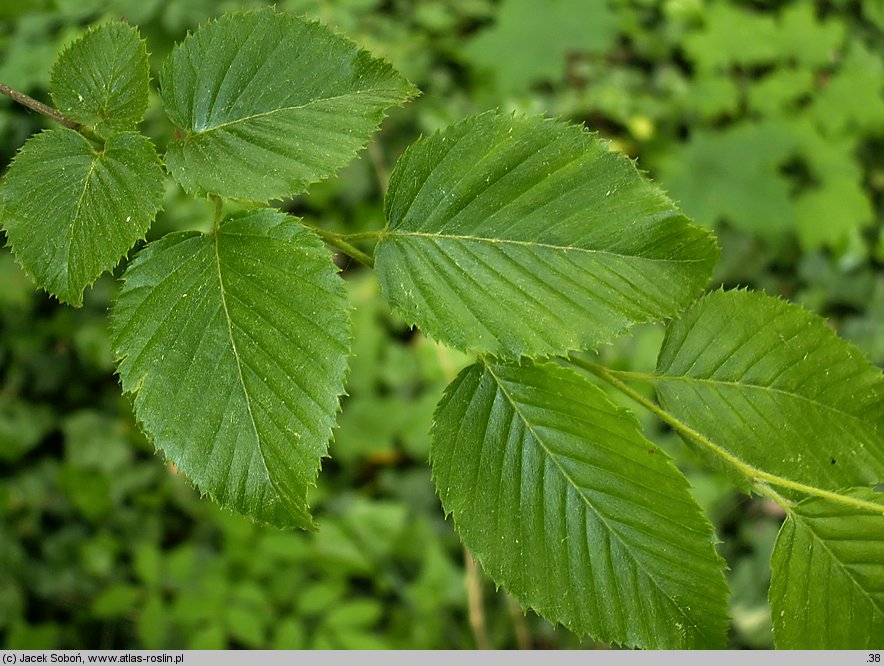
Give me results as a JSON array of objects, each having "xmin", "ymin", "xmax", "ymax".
[{"xmin": 770, "ymin": 488, "xmax": 884, "ymax": 650}]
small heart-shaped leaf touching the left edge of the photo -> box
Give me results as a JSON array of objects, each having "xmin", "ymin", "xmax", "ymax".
[{"xmin": 0, "ymin": 129, "xmax": 163, "ymax": 305}]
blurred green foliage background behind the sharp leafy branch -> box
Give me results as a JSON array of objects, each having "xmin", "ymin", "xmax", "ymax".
[{"xmin": 0, "ymin": 0, "xmax": 884, "ymax": 648}]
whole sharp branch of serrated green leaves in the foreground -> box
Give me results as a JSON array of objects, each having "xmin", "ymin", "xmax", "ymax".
[{"xmin": 0, "ymin": 9, "xmax": 884, "ymax": 648}]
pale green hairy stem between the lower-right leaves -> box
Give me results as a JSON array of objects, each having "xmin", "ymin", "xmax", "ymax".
[{"xmin": 569, "ymin": 356, "xmax": 884, "ymax": 514}]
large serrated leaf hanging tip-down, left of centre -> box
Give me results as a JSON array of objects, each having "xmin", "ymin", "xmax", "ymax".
[{"xmin": 112, "ymin": 209, "xmax": 350, "ymax": 527}]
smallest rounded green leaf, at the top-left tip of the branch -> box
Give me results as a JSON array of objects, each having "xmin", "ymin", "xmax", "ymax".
[{"xmin": 50, "ymin": 22, "xmax": 150, "ymax": 136}]
